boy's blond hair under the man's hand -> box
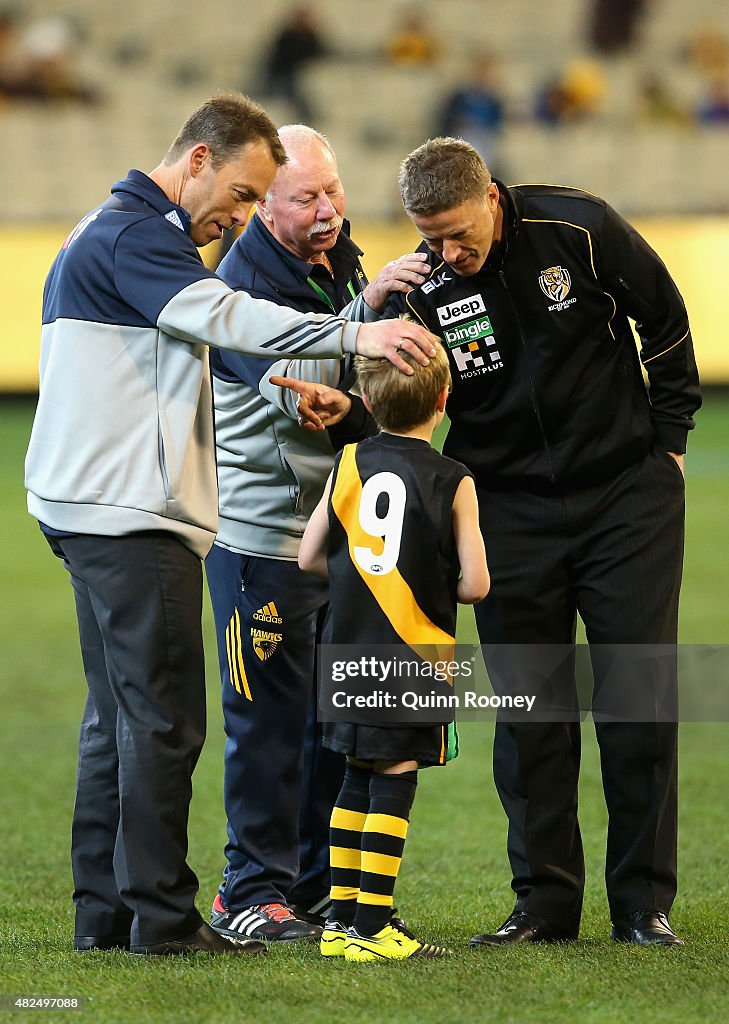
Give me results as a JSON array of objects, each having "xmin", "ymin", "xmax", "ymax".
[{"xmin": 354, "ymin": 344, "xmax": 451, "ymax": 433}]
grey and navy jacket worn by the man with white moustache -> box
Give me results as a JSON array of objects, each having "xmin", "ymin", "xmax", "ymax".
[{"xmin": 211, "ymin": 214, "xmax": 378, "ymax": 561}]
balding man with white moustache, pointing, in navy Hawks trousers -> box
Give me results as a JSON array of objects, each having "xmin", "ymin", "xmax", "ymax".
[{"xmin": 206, "ymin": 125, "xmax": 426, "ymax": 941}]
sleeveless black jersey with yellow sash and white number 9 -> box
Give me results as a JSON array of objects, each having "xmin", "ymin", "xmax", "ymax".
[{"xmin": 328, "ymin": 433, "xmax": 471, "ymax": 646}]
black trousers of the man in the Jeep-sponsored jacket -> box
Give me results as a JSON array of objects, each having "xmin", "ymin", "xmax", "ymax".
[{"xmin": 475, "ymin": 449, "xmax": 684, "ymax": 934}]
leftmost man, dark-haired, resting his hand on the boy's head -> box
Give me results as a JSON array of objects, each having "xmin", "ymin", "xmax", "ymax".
[{"xmin": 26, "ymin": 94, "xmax": 432, "ymax": 955}]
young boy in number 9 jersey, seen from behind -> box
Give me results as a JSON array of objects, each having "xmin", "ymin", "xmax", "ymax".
[{"xmin": 299, "ymin": 346, "xmax": 488, "ymax": 961}]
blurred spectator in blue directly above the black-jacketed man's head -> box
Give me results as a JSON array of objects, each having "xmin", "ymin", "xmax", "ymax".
[{"xmin": 436, "ymin": 54, "xmax": 504, "ymax": 160}]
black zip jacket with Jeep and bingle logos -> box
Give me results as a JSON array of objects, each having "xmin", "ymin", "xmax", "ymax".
[{"xmin": 385, "ymin": 182, "xmax": 701, "ymax": 493}]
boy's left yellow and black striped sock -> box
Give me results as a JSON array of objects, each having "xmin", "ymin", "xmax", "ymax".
[{"xmin": 329, "ymin": 763, "xmax": 372, "ymax": 928}]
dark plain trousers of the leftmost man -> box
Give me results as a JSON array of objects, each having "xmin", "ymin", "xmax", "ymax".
[{"xmin": 49, "ymin": 531, "xmax": 205, "ymax": 945}]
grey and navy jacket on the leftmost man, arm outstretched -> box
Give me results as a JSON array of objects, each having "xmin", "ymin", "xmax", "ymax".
[{"xmin": 26, "ymin": 171, "xmax": 357, "ymax": 556}]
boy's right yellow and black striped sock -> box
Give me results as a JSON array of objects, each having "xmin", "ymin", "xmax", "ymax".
[{"xmin": 354, "ymin": 771, "xmax": 418, "ymax": 935}]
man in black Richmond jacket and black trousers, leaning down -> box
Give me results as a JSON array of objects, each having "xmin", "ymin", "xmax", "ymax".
[{"xmin": 387, "ymin": 138, "xmax": 700, "ymax": 946}]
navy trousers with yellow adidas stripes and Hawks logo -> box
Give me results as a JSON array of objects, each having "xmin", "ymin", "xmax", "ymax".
[{"xmin": 205, "ymin": 544, "xmax": 344, "ymax": 910}]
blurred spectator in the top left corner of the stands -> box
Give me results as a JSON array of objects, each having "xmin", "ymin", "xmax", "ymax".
[{"xmin": 0, "ymin": 11, "xmax": 99, "ymax": 103}]
